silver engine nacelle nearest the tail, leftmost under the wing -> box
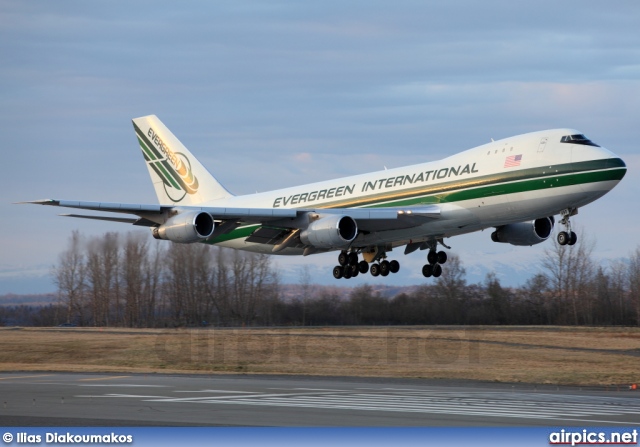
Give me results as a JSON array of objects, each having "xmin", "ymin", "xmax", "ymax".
[{"xmin": 151, "ymin": 211, "xmax": 215, "ymax": 244}]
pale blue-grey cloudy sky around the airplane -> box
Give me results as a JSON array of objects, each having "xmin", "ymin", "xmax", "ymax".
[{"xmin": 0, "ymin": 0, "xmax": 640, "ymax": 294}]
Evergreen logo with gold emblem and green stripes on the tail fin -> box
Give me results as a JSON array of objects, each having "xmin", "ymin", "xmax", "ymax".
[{"xmin": 136, "ymin": 126, "xmax": 199, "ymax": 203}]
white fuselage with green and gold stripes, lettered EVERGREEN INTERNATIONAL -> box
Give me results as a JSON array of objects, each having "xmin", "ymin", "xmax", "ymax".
[{"xmin": 203, "ymin": 129, "xmax": 619, "ymax": 254}]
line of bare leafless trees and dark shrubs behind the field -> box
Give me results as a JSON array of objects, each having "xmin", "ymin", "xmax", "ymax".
[{"xmin": 0, "ymin": 231, "xmax": 640, "ymax": 327}]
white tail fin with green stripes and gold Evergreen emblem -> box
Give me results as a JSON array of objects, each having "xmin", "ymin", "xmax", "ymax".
[{"xmin": 133, "ymin": 115, "xmax": 232, "ymax": 205}]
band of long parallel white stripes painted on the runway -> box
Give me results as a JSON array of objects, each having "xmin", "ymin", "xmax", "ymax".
[{"xmin": 78, "ymin": 388, "xmax": 640, "ymax": 424}]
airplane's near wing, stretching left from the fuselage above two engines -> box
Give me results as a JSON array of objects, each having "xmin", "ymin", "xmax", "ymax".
[{"xmin": 20, "ymin": 199, "xmax": 440, "ymax": 231}]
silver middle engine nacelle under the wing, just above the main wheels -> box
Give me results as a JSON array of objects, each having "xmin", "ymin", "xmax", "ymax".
[{"xmin": 300, "ymin": 215, "xmax": 358, "ymax": 248}]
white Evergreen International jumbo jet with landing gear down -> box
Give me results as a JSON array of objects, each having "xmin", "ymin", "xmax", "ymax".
[{"xmin": 22, "ymin": 115, "xmax": 626, "ymax": 279}]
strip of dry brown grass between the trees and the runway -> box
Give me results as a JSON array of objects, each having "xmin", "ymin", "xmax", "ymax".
[{"xmin": 0, "ymin": 326, "xmax": 640, "ymax": 386}]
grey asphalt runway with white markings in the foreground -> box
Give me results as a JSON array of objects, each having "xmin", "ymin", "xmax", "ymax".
[{"xmin": 0, "ymin": 373, "xmax": 640, "ymax": 427}]
